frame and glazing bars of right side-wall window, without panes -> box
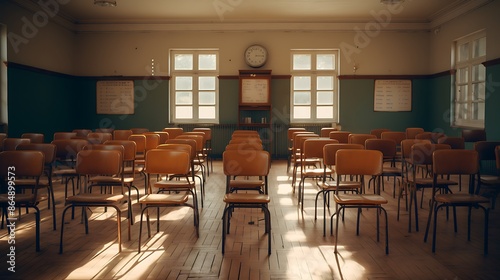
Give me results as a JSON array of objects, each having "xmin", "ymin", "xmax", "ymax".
[{"xmin": 450, "ymin": 30, "xmax": 487, "ymax": 129}]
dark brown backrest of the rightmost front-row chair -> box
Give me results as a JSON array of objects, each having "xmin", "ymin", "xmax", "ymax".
[{"xmin": 432, "ymin": 149, "xmax": 479, "ymax": 176}]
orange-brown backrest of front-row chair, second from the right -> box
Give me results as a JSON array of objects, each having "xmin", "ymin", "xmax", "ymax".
[{"xmin": 335, "ymin": 149, "xmax": 383, "ymax": 176}]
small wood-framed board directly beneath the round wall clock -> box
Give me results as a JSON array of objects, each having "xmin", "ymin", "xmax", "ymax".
[{"xmin": 240, "ymin": 78, "xmax": 270, "ymax": 104}]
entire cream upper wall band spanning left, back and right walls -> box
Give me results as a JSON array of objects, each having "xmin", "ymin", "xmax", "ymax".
[{"xmin": 0, "ymin": 1, "xmax": 500, "ymax": 76}]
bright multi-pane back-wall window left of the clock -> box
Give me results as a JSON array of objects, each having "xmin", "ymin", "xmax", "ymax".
[{"xmin": 170, "ymin": 50, "xmax": 219, "ymax": 123}]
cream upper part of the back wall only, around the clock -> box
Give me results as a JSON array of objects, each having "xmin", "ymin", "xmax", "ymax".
[{"xmin": 76, "ymin": 30, "xmax": 429, "ymax": 76}]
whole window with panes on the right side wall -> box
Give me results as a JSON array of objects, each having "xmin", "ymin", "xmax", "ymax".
[{"xmin": 453, "ymin": 31, "xmax": 486, "ymax": 128}]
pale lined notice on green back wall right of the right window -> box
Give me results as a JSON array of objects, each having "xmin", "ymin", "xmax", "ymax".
[{"xmin": 373, "ymin": 80, "xmax": 412, "ymax": 112}]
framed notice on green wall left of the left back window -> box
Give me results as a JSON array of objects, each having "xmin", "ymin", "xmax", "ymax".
[{"xmin": 96, "ymin": 81, "xmax": 134, "ymax": 115}]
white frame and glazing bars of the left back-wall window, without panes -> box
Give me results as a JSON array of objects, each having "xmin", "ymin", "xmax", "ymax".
[{"xmin": 169, "ymin": 49, "xmax": 219, "ymax": 124}]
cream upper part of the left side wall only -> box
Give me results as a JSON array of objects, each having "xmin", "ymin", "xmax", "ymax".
[{"xmin": 0, "ymin": 1, "xmax": 75, "ymax": 74}]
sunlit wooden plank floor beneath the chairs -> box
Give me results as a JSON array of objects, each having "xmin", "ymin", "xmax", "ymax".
[{"xmin": 0, "ymin": 161, "xmax": 500, "ymax": 279}]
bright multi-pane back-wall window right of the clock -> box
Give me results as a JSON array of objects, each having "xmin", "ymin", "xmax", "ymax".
[{"xmin": 290, "ymin": 50, "xmax": 338, "ymax": 123}]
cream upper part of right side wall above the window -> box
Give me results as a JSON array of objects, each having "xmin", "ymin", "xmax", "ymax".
[{"xmin": 429, "ymin": 1, "xmax": 500, "ymax": 73}]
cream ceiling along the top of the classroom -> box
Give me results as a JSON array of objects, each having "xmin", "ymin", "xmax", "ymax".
[{"xmin": 10, "ymin": 0, "xmax": 492, "ymax": 30}]
